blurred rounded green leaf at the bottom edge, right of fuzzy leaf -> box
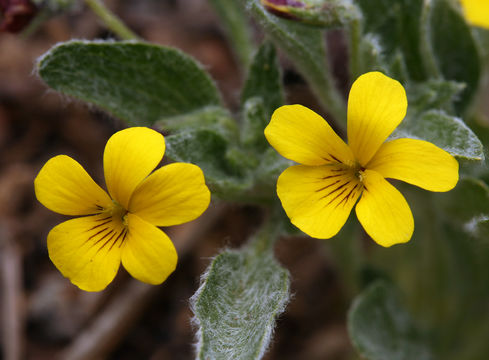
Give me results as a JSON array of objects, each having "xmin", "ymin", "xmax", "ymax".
[{"xmin": 348, "ymin": 281, "xmax": 434, "ymax": 360}]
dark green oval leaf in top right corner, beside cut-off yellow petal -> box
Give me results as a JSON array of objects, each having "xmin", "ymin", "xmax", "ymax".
[{"xmin": 429, "ymin": 0, "xmax": 481, "ymax": 113}]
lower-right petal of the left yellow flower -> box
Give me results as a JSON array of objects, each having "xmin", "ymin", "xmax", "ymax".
[{"xmin": 122, "ymin": 214, "xmax": 178, "ymax": 285}]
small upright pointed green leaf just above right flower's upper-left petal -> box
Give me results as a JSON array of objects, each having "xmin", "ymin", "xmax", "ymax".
[{"xmin": 241, "ymin": 42, "xmax": 284, "ymax": 118}]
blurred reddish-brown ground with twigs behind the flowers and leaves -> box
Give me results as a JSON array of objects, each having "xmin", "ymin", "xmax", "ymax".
[{"xmin": 0, "ymin": 0, "xmax": 353, "ymax": 360}]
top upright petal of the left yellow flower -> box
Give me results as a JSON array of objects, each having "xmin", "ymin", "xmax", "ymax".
[{"xmin": 104, "ymin": 127, "xmax": 165, "ymax": 209}]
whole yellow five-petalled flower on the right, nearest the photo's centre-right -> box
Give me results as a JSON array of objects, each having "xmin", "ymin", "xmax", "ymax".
[{"xmin": 265, "ymin": 72, "xmax": 458, "ymax": 247}]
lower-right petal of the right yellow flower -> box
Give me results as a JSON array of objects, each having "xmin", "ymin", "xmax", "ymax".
[{"xmin": 355, "ymin": 170, "xmax": 414, "ymax": 247}]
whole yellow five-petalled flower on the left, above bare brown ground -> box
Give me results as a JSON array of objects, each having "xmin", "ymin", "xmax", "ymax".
[{"xmin": 34, "ymin": 127, "xmax": 210, "ymax": 291}]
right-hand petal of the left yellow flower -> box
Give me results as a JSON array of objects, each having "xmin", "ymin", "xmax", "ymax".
[{"xmin": 129, "ymin": 163, "xmax": 211, "ymax": 226}]
